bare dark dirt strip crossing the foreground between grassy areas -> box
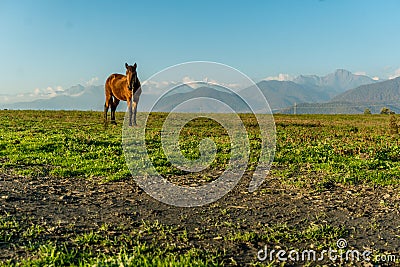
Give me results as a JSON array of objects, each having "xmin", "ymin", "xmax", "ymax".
[{"xmin": 0, "ymin": 175, "xmax": 400, "ymax": 265}]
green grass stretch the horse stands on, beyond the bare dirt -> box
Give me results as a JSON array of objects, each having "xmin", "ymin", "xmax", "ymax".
[{"xmin": 0, "ymin": 111, "xmax": 400, "ymax": 186}]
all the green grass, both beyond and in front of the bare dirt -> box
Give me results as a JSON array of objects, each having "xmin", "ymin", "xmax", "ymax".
[{"xmin": 0, "ymin": 111, "xmax": 400, "ymax": 266}]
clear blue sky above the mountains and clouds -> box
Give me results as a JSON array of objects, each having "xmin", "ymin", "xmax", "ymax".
[{"xmin": 0, "ymin": 0, "xmax": 400, "ymax": 94}]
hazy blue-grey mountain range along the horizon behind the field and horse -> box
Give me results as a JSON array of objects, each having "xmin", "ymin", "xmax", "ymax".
[{"xmin": 0, "ymin": 69, "xmax": 400, "ymax": 113}]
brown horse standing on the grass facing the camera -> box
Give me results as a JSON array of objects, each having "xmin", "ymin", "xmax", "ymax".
[{"xmin": 104, "ymin": 63, "xmax": 142, "ymax": 126}]
